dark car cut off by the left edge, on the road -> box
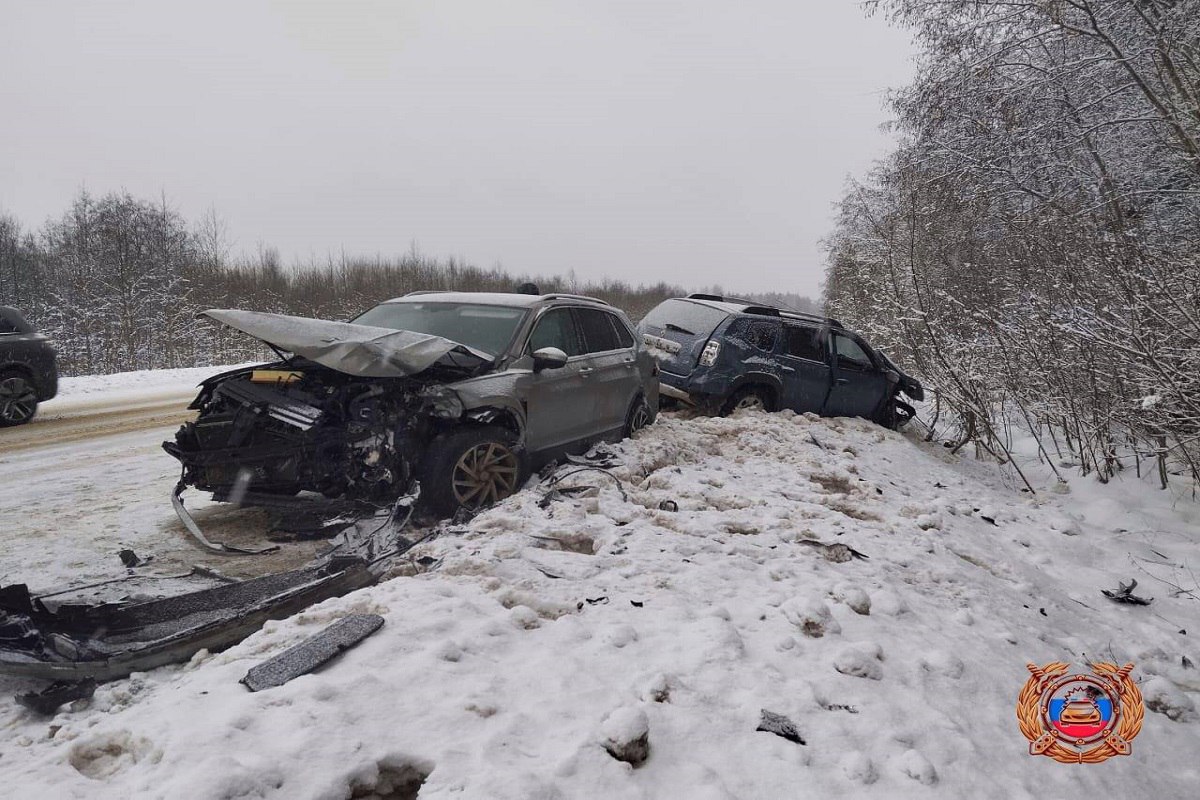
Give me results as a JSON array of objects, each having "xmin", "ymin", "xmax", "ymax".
[{"xmin": 0, "ymin": 306, "xmax": 59, "ymax": 428}]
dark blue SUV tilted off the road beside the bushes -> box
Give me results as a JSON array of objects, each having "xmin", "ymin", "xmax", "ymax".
[{"xmin": 637, "ymin": 294, "xmax": 925, "ymax": 428}]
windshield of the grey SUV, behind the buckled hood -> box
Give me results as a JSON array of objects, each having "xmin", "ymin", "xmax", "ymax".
[{"xmin": 353, "ymin": 302, "xmax": 526, "ymax": 355}]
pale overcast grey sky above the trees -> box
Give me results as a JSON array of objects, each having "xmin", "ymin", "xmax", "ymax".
[{"xmin": 0, "ymin": 0, "xmax": 911, "ymax": 294}]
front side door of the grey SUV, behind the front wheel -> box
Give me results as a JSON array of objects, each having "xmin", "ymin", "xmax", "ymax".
[{"xmin": 524, "ymin": 306, "xmax": 598, "ymax": 452}]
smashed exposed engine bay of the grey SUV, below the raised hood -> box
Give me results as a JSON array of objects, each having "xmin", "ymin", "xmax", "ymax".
[{"xmin": 163, "ymin": 361, "xmax": 441, "ymax": 503}]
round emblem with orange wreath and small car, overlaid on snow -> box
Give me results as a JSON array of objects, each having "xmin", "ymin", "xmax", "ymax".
[{"xmin": 1016, "ymin": 661, "xmax": 1146, "ymax": 764}]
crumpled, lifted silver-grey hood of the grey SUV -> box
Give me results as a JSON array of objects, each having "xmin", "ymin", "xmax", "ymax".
[{"xmin": 200, "ymin": 308, "xmax": 492, "ymax": 378}]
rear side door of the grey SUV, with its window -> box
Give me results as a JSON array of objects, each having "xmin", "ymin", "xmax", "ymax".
[{"xmin": 575, "ymin": 307, "xmax": 641, "ymax": 435}]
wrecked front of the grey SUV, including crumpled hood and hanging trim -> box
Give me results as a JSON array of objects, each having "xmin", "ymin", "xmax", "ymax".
[{"xmin": 163, "ymin": 312, "xmax": 491, "ymax": 542}]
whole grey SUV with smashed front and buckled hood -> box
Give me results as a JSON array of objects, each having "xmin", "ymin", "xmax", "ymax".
[{"xmin": 163, "ymin": 293, "xmax": 659, "ymax": 513}]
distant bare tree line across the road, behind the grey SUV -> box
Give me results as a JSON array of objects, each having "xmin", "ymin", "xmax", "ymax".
[{"xmin": 0, "ymin": 192, "xmax": 809, "ymax": 375}]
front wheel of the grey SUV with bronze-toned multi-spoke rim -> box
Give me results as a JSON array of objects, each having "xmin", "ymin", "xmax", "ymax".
[{"xmin": 421, "ymin": 425, "xmax": 526, "ymax": 517}]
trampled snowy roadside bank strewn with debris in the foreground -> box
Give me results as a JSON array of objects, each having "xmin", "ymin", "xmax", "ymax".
[{"xmin": 0, "ymin": 379, "xmax": 1200, "ymax": 800}]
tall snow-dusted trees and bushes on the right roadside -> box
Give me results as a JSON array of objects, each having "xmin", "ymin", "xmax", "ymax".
[{"xmin": 824, "ymin": 0, "xmax": 1200, "ymax": 487}]
